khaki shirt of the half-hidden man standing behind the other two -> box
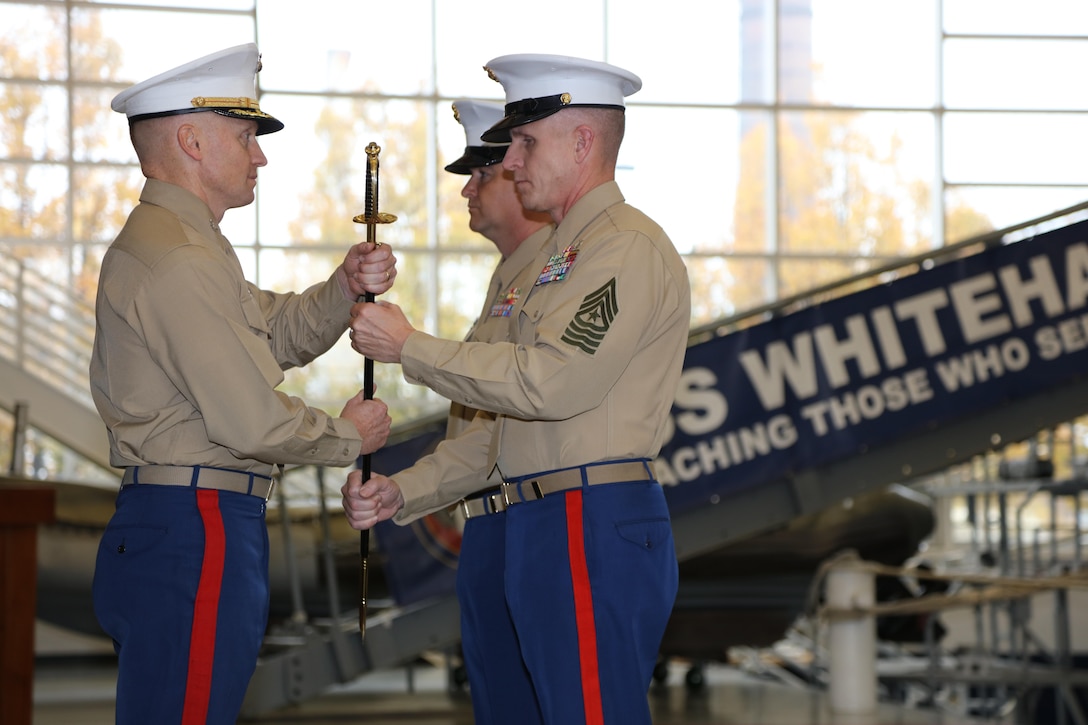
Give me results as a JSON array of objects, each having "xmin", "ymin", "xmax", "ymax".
[{"xmin": 392, "ymin": 225, "xmax": 554, "ymax": 511}]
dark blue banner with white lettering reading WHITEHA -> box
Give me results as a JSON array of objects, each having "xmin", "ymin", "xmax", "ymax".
[{"xmin": 657, "ymin": 222, "xmax": 1088, "ymax": 514}]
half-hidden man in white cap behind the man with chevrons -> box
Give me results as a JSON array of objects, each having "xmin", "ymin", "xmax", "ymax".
[{"xmin": 356, "ymin": 99, "xmax": 553, "ymax": 723}]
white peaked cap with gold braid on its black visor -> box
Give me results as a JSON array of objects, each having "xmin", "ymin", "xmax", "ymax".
[{"xmin": 110, "ymin": 42, "xmax": 283, "ymax": 134}]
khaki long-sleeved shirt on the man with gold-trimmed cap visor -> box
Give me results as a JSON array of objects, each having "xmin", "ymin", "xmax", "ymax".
[{"xmin": 90, "ymin": 180, "xmax": 361, "ymax": 476}]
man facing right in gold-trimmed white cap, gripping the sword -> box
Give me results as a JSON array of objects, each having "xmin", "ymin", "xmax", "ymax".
[{"xmin": 90, "ymin": 44, "xmax": 396, "ymax": 725}]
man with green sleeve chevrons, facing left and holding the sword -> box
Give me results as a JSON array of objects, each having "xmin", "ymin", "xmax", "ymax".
[{"xmin": 343, "ymin": 54, "xmax": 691, "ymax": 725}]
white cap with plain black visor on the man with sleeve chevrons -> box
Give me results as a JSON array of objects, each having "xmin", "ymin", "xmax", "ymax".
[{"xmin": 483, "ymin": 53, "xmax": 642, "ymax": 142}]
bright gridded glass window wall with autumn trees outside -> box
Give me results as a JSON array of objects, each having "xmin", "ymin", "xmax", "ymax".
[{"xmin": 0, "ymin": 0, "xmax": 1088, "ymax": 423}]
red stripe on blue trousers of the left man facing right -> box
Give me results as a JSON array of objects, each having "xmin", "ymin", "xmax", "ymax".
[{"xmin": 182, "ymin": 489, "xmax": 226, "ymax": 725}]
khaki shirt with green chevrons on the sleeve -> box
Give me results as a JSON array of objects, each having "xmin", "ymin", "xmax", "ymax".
[{"xmin": 396, "ymin": 182, "xmax": 691, "ymax": 523}]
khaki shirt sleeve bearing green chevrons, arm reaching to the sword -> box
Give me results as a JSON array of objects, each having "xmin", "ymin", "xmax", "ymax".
[{"xmin": 401, "ymin": 231, "xmax": 687, "ymax": 420}]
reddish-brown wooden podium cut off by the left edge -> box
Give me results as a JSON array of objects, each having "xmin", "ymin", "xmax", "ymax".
[{"xmin": 0, "ymin": 478, "xmax": 55, "ymax": 725}]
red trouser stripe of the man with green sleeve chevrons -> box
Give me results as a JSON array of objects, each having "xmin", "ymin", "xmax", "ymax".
[{"xmin": 565, "ymin": 489, "xmax": 605, "ymax": 725}]
